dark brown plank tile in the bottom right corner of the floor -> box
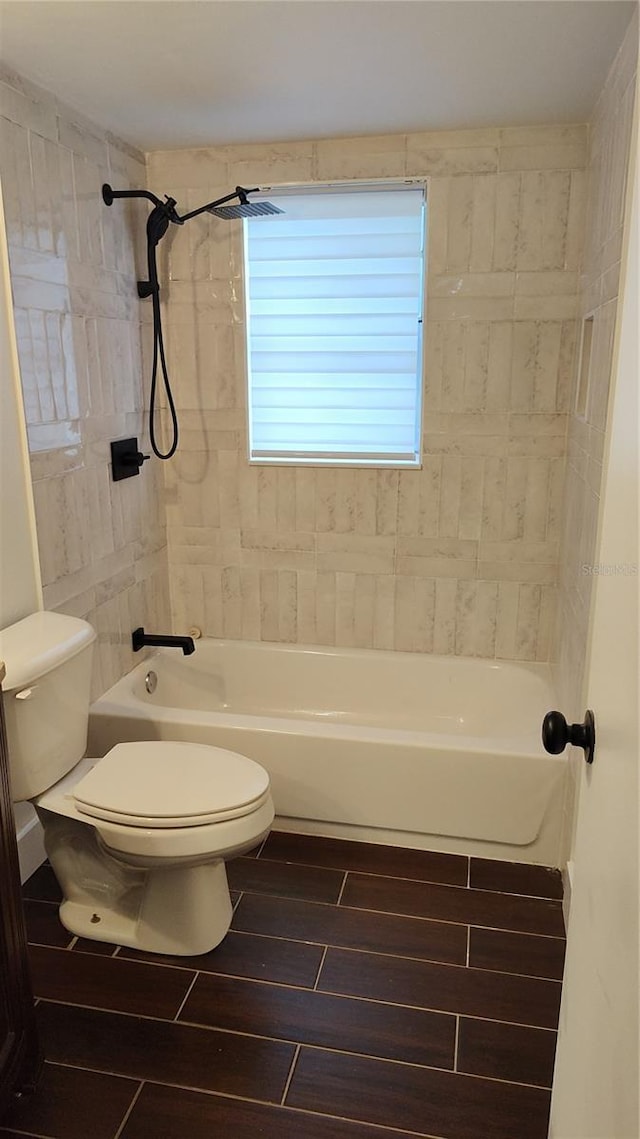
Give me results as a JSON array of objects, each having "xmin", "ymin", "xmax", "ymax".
[{"xmin": 286, "ymin": 1048, "xmax": 550, "ymax": 1139}]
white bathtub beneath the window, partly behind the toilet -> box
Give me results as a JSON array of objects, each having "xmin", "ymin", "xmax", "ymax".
[{"xmin": 89, "ymin": 639, "xmax": 566, "ymax": 866}]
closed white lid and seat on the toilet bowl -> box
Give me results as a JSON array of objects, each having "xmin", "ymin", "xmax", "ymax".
[{"xmin": 73, "ymin": 740, "xmax": 269, "ymax": 827}]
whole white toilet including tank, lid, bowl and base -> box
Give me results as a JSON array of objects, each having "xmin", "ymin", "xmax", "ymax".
[{"xmin": 0, "ymin": 612, "xmax": 273, "ymax": 956}]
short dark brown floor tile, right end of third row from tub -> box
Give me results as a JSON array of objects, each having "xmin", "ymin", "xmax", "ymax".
[{"xmin": 469, "ymin": 927, "xmax": 565, "ymax": 981}]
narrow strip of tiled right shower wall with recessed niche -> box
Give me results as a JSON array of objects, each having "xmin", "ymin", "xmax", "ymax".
[{"xmin": 552, "ymin": 15, "xmax": 638, "ymax": 856}]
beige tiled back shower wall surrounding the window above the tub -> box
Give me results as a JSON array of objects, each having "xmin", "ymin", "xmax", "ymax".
[{"xmin": 148, "ymin": 125, "xmax": 588, "ymax": 661}]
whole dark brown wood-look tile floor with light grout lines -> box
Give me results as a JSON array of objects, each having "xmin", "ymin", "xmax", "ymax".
[{"xmin": 0, "ymin": 833, "xmax": 564, "ymax": 1139}]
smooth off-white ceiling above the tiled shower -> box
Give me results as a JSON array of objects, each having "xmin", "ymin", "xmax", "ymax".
[{"xmin": 0, "ymin": 0, "xmax": 637, "ymax": 150}]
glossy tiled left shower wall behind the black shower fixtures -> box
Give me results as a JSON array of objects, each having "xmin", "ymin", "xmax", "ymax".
[{"xmin": 0, "ymin": 71, "xmax": 170, "ymax": 695}]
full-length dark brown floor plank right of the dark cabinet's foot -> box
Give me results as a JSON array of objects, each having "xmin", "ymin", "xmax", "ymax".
[{"xmin": 36, "ymin": 1001, "xmax": 295, "ymax": 1102}]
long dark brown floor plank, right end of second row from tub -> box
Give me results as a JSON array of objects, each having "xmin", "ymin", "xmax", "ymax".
[{"xmin": 341, "ymin": 859, "xmax": 565, "ymax": 937}]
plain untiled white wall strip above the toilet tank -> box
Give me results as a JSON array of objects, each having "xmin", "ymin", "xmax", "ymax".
[{"xmin": 0, "ymin": 178, "xmax": 42, "ymax": 629}]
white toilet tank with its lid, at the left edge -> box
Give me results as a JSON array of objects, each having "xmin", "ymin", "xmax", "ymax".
[{"xmin": 0, "ymin": 612, "xmax": 96, "ymax": 803}]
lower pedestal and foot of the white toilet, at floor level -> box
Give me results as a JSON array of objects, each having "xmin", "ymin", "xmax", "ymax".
[{"xmin": 59, "ymin": 860, "xmax": 233, "ymax": 957}]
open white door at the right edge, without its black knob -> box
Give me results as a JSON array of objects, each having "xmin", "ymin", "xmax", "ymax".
[{"xmin": 550, "ymin": 111, "xmax": 640, "ymax": 1139}]
